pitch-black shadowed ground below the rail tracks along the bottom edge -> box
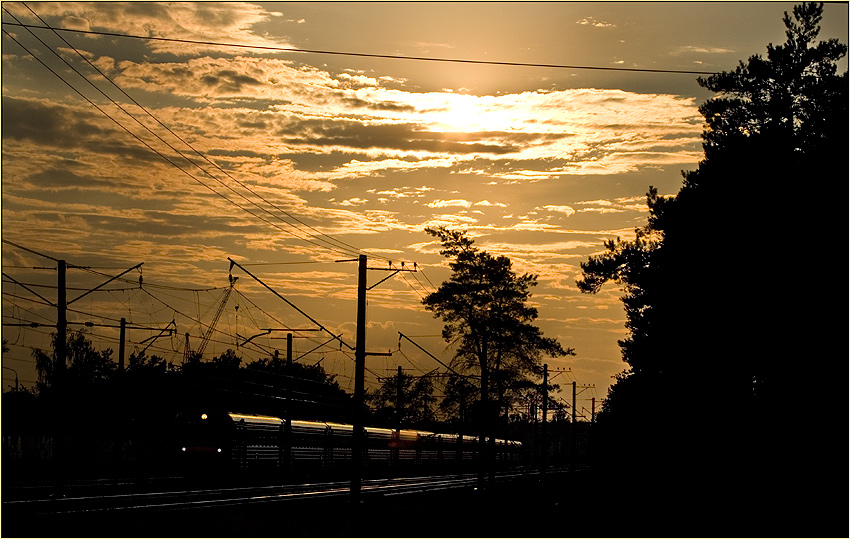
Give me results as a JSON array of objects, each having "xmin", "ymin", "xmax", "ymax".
[{"xmin": 2, "ymin": 471, "xmax": 847, "ymax": 537}]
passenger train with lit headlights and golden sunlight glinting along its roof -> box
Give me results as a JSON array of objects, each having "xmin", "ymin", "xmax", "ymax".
[{"xmin": 175, "ymin": 411, "xmax": 523, "ymax": 473}]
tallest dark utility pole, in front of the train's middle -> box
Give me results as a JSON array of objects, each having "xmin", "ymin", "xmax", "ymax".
[{"xmin": 351, "ymin": 255, "xmax": 366, "ymax": 500}]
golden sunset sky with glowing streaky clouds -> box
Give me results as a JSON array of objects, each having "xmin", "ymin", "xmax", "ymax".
[{"xmin": 2, "ymin": 2, "xmax": 848, "ymax": 416}]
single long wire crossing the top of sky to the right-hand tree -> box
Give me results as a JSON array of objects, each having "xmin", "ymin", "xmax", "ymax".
[{"xmin": 3, "ymin": 22, "xmax": 715, "ymax": 75}]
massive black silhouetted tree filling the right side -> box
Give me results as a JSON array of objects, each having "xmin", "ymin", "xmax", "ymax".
[{"xmin": 577, "ymin": 4, "xmax": 848, "ymax": 534}]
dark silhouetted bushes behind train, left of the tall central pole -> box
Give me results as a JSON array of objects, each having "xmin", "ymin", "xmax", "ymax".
[{"xmin": 18, "ymin": 330, "xmax": 351, "ymax": 430}]
